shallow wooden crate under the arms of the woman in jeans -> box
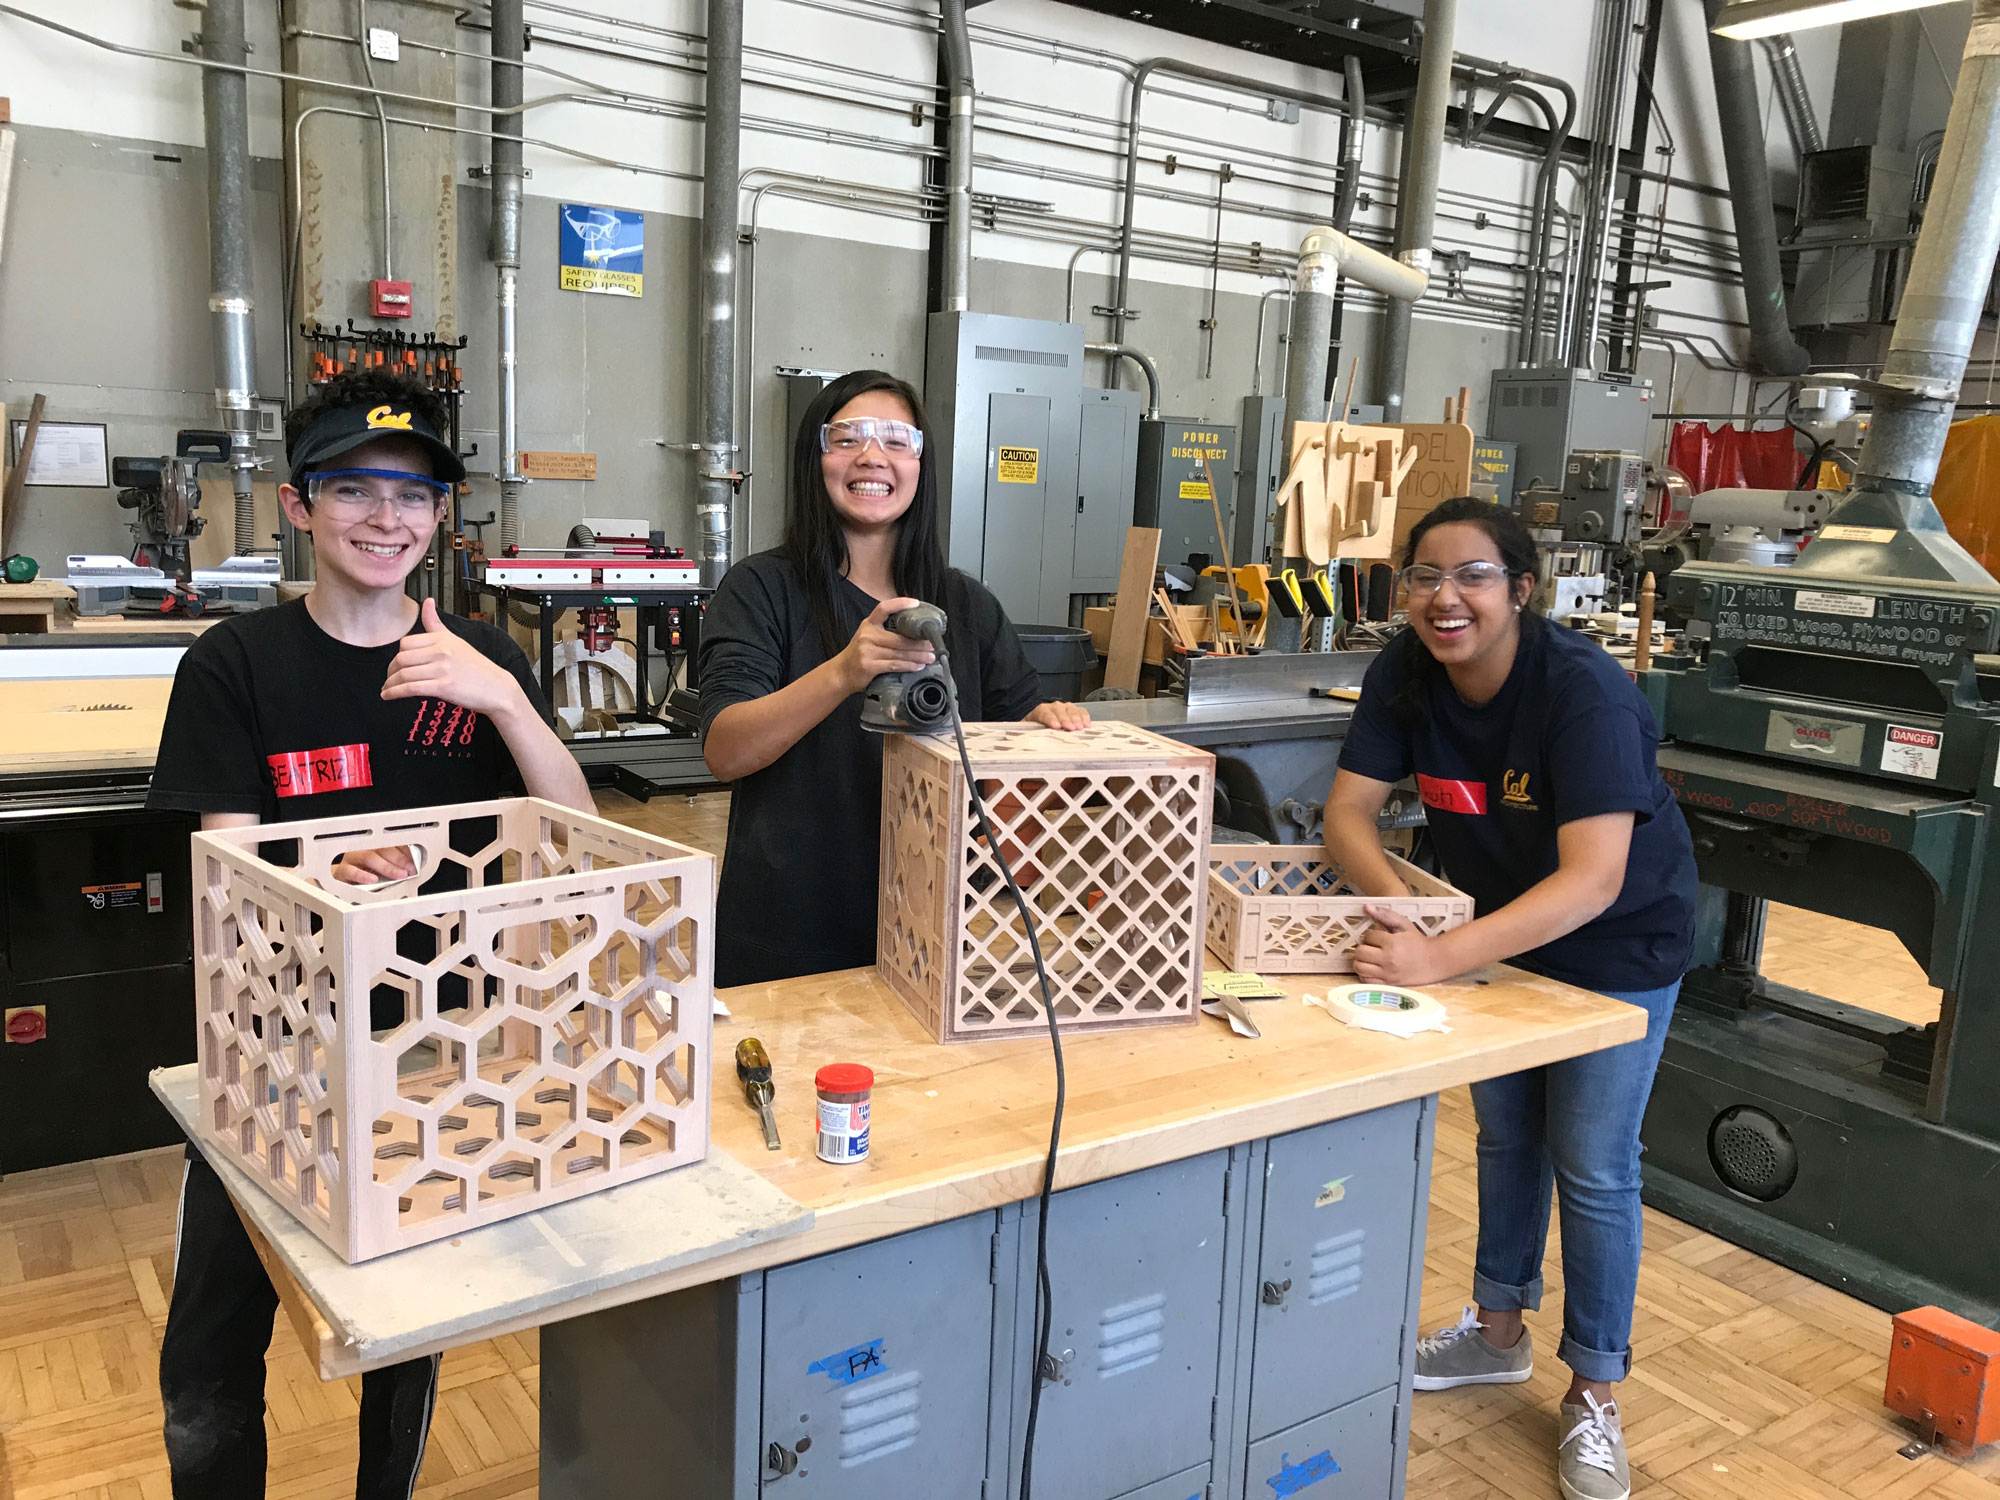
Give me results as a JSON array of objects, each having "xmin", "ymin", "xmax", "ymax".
[{"xmin": 1208, "ymin": 844, "xmax": 1472, "ymax": 974}]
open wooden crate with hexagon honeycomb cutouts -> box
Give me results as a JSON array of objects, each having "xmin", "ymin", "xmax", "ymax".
[{"xmin": 194, "ymin": 798, "xmax": 716, "ymax": 1262}]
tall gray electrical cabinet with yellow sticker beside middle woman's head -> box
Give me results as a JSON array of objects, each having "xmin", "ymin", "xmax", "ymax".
[{"xmin": 924, "ymin": 312, "xmax": 1084, "ymax": 624}]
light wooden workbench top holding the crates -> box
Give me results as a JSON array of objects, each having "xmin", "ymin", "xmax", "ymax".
[{"xmin": 234, "ymin": 968, "xmax": 1646, "ymax": 1380}]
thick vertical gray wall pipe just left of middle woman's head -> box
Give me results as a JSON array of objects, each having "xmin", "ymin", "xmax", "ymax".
[{"xmin": 694, "ymin": 0, "xmax": 744, "ymax": 586}]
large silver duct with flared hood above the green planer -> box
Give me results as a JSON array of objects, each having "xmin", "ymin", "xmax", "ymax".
[{"xmin": 1798, "ymin": 0, "xmax": 2000, "ymax": 584}]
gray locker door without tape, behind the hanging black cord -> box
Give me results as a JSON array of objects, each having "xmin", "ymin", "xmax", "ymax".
[{"xmin": 1008, "ymin": 1152, "xmax": 1228, "ymax": 1498}]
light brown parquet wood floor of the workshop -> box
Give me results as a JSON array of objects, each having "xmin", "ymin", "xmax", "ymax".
[{"xmin": 0, "ymin": 792, "xmax": 2000, "ymax": 1500}]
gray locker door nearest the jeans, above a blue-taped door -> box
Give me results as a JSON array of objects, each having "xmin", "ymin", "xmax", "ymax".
[{"xmin": 1248, "ymin": 1100, "xmax": 1432, "ymax": 1448}]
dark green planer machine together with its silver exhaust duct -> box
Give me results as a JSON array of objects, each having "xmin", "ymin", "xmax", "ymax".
[{"xmin": 1640, "ymin": 0, "xmax": 2000, "ymax": 1326}]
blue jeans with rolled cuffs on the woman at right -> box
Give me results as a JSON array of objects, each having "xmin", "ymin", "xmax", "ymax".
[{"xmin": 1472, "ymin": 980, "xmax": 1680, "ymax": 1380}]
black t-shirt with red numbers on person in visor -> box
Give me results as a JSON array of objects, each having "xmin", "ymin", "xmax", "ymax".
[{"xmin": 146, "ymin": 600, "xmax": 542, "ymax": 822}]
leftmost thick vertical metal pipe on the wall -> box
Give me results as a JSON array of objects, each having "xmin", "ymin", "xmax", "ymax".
[{"xmin": 202, "ymin": 0, "xmax": 256, "ymax": 552}]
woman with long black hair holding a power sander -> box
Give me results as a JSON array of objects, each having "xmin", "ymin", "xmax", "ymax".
[{"xmin": 702, "ymin": 370, "xmax": 1090, "ymax": 986}]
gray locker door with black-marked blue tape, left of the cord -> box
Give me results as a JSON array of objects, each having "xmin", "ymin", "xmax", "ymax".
[{"xmin": 760, "ymin": 1214, "xmax": 996, "ymax": 1500}]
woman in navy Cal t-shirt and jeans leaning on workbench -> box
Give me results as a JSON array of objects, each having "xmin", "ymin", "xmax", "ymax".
[{"xmin": 1326, "ymin": 500, "xmax": 1696, "ymax": 1500}]
